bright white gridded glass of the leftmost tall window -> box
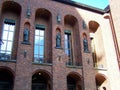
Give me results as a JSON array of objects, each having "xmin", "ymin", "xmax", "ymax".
[{"xmin": 0, "ymin": 22, "xmax": 15, "ymax": 59}]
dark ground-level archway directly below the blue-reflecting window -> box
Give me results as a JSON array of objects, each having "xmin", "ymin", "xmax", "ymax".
[{"xmin": 32, "ymin": 71, "xmax": 52, "ymax": 90}]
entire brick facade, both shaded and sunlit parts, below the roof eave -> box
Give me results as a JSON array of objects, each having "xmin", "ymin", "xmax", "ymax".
[{"xmin": 0, "ymin": 0, "xmax": 119, "ymax": 90}]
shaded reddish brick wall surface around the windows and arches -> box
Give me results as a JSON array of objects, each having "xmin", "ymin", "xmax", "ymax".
[{"xmin": 0, "ymin": 0, "xmax": 95, "ymax": 90}]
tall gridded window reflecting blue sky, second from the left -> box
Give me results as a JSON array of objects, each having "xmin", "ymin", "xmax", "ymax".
[{"xmin": 34, "ymin": 25, "xmax": 45, "ymax": 63}]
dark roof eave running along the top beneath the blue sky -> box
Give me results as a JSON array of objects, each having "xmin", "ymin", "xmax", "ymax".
[{"xmin": 53, "ymin": 0, "xmax": 110, "ymax": 14}]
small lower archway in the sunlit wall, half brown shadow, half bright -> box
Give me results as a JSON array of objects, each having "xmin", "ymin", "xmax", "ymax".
[{"xmin": 95, "ymin": 74, "xmax": 107, "ymax": 90}]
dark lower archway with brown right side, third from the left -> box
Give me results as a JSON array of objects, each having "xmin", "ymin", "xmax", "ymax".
[{"xmin": 67, "ymin": 73, "xmax": 82, "ymax": 90}]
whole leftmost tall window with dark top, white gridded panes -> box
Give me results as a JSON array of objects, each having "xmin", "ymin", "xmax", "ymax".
[{"xmin": 0, "ymin": 19, "xmax": 15, "ymax": 60}]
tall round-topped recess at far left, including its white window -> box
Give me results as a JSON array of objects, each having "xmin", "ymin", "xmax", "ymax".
[{"xmin": 0, "ymin": 1, "xmax": 21, "ymax": 60}]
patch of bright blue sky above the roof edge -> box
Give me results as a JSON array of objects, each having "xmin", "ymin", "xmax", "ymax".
[{"xmin": 72, "ymin": 0, "xmax": 109, "ymax": 9}]
